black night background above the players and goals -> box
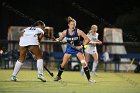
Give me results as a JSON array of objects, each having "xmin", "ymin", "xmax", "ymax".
[{"xmin": 0, "ymin": 0, "xmax": 140, "ymax": 42}]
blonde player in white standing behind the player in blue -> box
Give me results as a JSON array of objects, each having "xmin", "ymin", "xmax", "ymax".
[{"xmin": 81, "ymin": 25, "xmax": 102, "ymax": 76}]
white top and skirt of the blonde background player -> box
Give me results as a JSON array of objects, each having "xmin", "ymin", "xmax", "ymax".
[{"xmin": 85, "ymin": 33, "xmax": 99, "ymax": 54}]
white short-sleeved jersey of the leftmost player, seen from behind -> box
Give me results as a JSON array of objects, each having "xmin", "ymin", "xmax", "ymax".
[{"xmin": 19, "ymin": 27, "xmax": 44, "ymax": 46}]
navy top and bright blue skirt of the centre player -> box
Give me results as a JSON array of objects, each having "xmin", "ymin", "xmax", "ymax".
[{"xmin": 65, "ymin": 29, "xmax": 82, "ymax": 55}]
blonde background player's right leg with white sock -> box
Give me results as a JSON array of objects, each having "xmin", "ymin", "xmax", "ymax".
[{"xmin": 92, "ymin": 52, "xmax": 98, "ymax": 76}]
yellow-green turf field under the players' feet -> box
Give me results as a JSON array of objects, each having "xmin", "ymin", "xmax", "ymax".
[{"xmin": 0, "ymin": 69, "xmax": 140, "ymax": 93}]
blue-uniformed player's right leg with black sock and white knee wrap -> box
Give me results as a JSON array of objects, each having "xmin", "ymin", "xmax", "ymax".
[{"xmin": 77, "ymin": 52, "xmax": 95, "ymax": 83}]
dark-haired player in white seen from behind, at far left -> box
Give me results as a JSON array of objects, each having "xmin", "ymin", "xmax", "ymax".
[{"xmin": 11, "ymin": 20, "xmax": 46, "ymax": 82}]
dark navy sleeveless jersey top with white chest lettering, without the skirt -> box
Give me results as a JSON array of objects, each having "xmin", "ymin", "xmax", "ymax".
[{"xmin": 66, "ymin": 28, "xmax": 81, "ymax": 46}]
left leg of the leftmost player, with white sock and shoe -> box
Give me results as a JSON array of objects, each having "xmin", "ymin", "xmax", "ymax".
[{"xmin": 11, "ymin": 46, "xmax": 28, "ymax": 81}]
